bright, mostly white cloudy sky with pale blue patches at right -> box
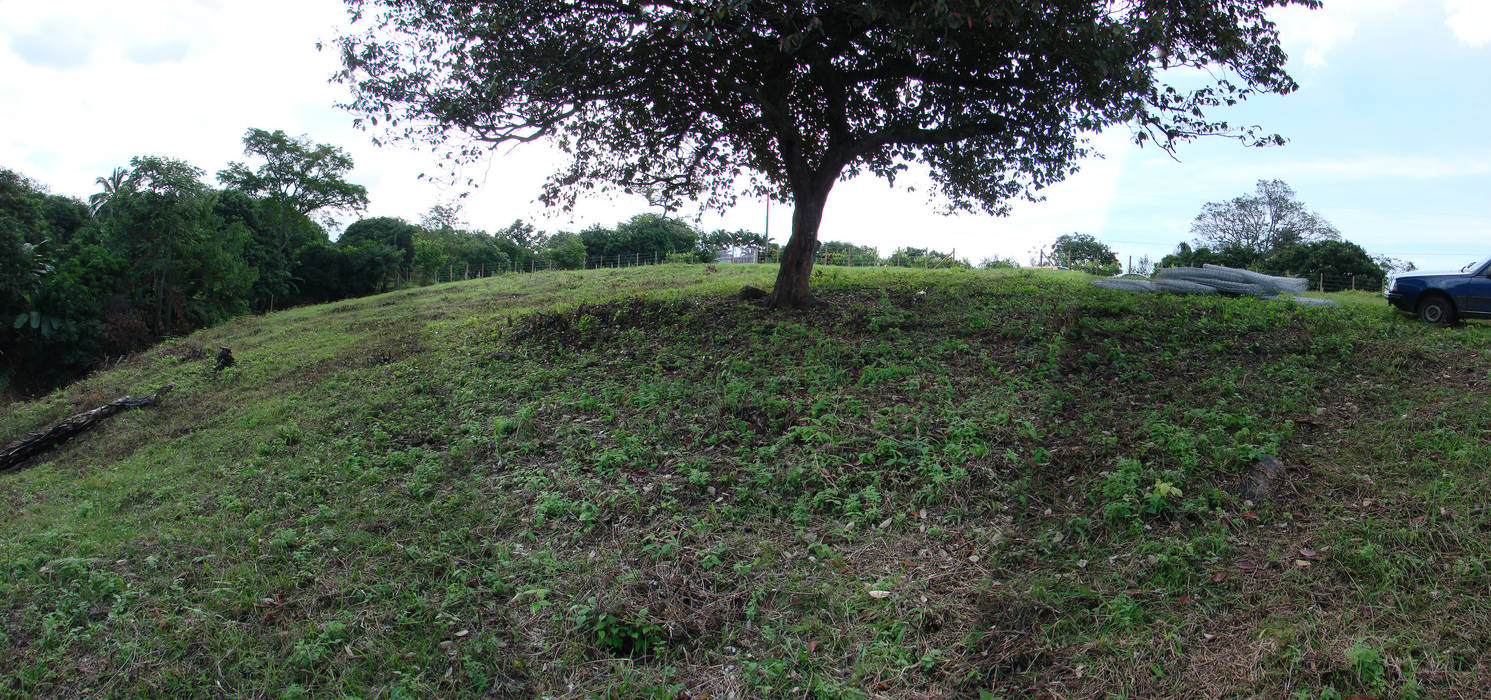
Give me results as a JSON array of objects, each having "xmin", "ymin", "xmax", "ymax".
[{"xmin": 0, "ymin": 0, "xmax": 1491, "ymax": 267}]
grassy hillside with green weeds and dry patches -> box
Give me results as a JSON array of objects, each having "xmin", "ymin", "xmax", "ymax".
[{"xmin": 0, "ymin": 266, "xmax": 1491, "ymax": 697}]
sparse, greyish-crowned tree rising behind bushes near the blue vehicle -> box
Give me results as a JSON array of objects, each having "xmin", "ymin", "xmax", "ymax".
[{"xmin": 1191, "ymin": 179, "xmax": 1340, "ymax": 258}]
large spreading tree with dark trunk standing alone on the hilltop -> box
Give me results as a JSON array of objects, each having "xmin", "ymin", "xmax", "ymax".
[{"xmin": 338, "ymin": 0, "xmax": 1320, "ymax": 306}]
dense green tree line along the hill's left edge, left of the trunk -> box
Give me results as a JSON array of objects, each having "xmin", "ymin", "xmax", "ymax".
[{"xmin": 0, "ymin": 128, "xmax": 768, "ymax": 396}]
